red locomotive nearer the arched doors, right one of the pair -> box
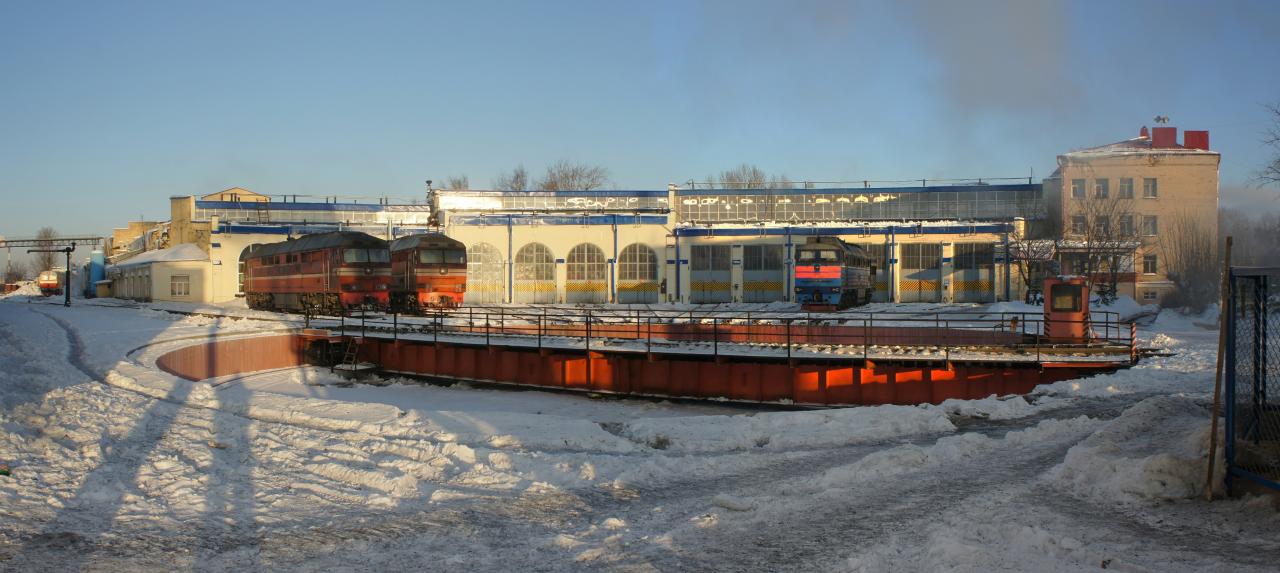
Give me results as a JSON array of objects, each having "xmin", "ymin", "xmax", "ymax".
[{"xmin": 390, "ymin": 233, "xmax": 467, "ymax": 313}]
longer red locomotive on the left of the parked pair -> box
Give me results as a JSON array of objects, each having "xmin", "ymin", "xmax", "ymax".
[{"xmin": 244, "ymin": 232, "xmax": 392, "ymax": 313}]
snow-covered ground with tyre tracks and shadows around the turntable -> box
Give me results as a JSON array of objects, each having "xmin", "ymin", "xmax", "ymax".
[{"xmin": 0, "ymin": 294, "xmax": 1280, "ymax": 572}]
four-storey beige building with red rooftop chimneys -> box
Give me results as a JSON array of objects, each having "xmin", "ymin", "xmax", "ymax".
[{"xmin": 1044, "ymin": 127, "xmax": 1221, "ymax": 303}]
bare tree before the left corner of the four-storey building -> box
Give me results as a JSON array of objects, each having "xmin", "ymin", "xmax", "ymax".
[{"xmin": 1057, "ymin": 187, "xmax": 1142, "ymax": 303}]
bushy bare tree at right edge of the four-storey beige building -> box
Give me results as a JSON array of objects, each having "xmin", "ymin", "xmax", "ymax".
[{"xmin": 1156, "ymin": 211, "xmax": 1220, "ymax": 312}]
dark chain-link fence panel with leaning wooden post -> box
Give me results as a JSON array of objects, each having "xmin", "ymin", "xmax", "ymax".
[{"xmin": 1226, "ymin": 269, "xmax": 1280, "ymax": 490}]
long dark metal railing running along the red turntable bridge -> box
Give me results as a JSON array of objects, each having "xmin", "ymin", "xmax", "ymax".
[{"xmin": 308, "ymin": 306, "xmax": 1137, "ymax": 362}]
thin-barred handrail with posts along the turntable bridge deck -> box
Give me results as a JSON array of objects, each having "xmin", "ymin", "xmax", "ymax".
[{"xmin": 311, "ymin": 308, "xmax": 1137, "ymax": 359}]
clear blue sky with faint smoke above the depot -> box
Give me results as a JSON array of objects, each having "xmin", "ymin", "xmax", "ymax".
[{"xmin": 0, "ymin": 0, "xmax": 1280, "ymax": 237}]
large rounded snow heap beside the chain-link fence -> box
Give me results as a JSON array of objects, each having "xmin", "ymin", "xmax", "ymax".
[{"xmin": 1051, "ymin": 396, "xmax": 1222, "ymax": 501}]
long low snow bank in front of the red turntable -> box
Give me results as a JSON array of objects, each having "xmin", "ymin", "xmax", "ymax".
[{"xmin": 621, "ymin": 405, "xmax": 955, "ymax": 453}]
